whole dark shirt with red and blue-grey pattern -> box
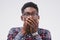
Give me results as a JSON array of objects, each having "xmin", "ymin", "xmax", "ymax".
[{"xmin": 7, "ymin": 27, "xmax": 51, "ymax": 40}]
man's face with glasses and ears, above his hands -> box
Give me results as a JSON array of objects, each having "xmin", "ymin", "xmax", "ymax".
[{"xmin": 21, "ymin": 7, "xmax": 39, "ymax": 21}]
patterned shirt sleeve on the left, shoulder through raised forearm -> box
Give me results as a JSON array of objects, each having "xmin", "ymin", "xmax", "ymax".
[{"xmin": 7, "ymin": 28, "xmax": 23, "ymax": 40}]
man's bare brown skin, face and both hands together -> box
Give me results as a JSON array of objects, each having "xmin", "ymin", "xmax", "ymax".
[{"xmin": 21, "ymin": 7, "xmax": 39, "ymax": 35}]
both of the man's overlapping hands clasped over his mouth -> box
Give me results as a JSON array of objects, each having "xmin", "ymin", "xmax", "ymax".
[{"xmin": 20, "ymin": 17, "xmax": 38, "ymax": 34}]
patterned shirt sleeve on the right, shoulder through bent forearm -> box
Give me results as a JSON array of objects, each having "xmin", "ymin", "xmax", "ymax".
[{"xmin": 35, "ymin": 30, "xmax": 51, "ymax": 40}]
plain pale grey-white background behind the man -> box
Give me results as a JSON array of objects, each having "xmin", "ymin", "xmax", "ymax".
[{"xmin": 0, "ymin": 0, "xmax": 60, "ymax": 40}]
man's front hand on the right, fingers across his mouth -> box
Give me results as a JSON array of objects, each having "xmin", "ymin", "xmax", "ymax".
[{"xmin": 26, "ymin": 17, "xmax": 38, "ymax": 33}]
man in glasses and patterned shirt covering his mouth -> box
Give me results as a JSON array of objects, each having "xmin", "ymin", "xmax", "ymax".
[{"xmin": 7, "ymin": 2, "xmax": 51, "ymax": 40}]
